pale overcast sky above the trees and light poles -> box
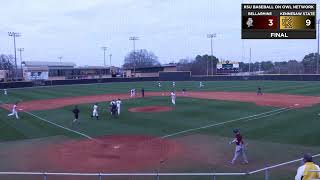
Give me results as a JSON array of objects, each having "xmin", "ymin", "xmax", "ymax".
[{"xmin": 0, "ymin": 0, "xmax": 320, "ymax": 66}]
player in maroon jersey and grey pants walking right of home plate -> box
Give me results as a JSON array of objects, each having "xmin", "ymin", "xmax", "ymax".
[{"xmin": 230, "ymin": 129, "xmax": 249, "ymax": 164}]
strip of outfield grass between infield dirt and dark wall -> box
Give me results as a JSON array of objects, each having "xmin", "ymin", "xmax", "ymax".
[{"xmin": 0, "ymin": 81, "xmax": 320, "ymax": 102}]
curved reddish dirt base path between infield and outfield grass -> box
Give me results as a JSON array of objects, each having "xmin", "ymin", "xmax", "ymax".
[{"xmin": 1, "ymin": 92, "xmax": 320, "ymax": 111}]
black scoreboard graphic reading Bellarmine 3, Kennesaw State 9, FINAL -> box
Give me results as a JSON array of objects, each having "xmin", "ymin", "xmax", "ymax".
[{"xmin": 241, "ymin": 4, "xmax": 317, "ymax": 39}]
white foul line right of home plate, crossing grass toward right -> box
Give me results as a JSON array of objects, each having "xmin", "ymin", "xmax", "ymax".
[{"xmin": 160, "ymin": 108, "xmax": 288, "ymax": 139}]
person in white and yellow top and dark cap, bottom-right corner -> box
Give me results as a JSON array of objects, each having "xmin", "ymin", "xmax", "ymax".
[{"xmin": 295, "ymin": 154, "xmax": 320, "ymax": 180}]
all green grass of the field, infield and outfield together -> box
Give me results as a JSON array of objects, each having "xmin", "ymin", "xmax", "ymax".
[{"xmin": 0, "ymin": 81, "xmax": 320, "ymax": 179}]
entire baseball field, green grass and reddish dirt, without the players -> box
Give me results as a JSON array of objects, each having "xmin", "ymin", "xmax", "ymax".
[{"xmin": 0, "ymin": 81, "xmax": 320, "ymax": 180}]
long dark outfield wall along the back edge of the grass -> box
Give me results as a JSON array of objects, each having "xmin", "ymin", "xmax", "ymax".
[{"xmin": 0, "ymin": 74, "xmax": 320, "ymax": 89}]
